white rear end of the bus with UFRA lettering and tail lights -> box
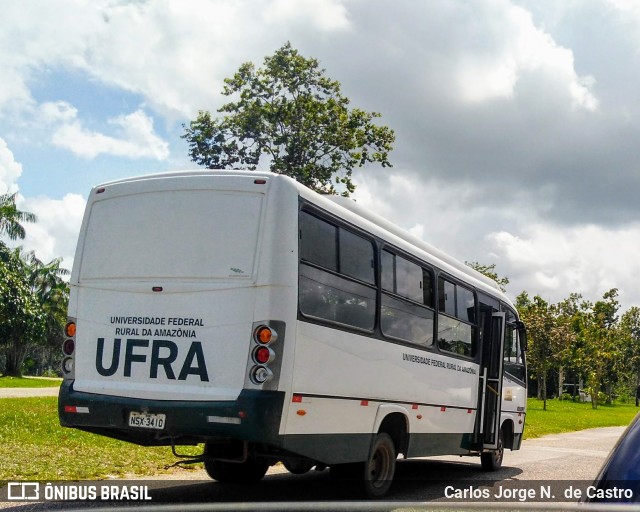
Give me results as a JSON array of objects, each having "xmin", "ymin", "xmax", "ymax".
[{"xmin": 59, "ymin": 172, "xmax": 296, "ymax": 456}]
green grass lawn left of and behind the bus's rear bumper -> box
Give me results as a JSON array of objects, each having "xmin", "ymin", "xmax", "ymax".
[{"xmin": 0, "ymin": 397, "xmax": 201, "ymax": 480}]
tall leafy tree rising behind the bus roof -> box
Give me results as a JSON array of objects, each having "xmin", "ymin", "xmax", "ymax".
[{"xmin": 182, "ymin": 43, "xmax": 395, "ymax": 195}]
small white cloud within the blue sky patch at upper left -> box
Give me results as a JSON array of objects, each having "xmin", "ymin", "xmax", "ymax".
[{"xmin": 40, "ymin": 102, "xmax": 169, "ymax": 160}]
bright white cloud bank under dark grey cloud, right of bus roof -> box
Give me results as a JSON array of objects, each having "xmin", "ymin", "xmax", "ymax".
[{"xmin": 355, "ymin": 170, "xmax": 640, "ymax": 309}]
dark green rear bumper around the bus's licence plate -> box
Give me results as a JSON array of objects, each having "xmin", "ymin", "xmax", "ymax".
[{"xmin": 58, "ymin": 380, "xmax": 284, "ymax": 446}]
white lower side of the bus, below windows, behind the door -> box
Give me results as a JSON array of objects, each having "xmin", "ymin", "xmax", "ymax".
[{"xmin": 285, "ymin": 322, "xmax": 478, "ymax": 463}]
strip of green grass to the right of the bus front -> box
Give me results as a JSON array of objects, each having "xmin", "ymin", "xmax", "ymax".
[{"xmin": 524, "ymin": 398, "xmax": 640, "ymax": 439}]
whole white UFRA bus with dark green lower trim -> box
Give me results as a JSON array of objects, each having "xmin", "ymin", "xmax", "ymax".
[{"xmin": 59, "ymin": 170, "xmax": 526, "ymax": 497}]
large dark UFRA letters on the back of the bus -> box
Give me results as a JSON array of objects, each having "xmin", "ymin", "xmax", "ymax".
[{"xmin": 96, "ymin": 338, "xmax": 209, "ymax": 382}]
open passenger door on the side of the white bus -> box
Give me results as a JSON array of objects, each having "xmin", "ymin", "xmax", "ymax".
[{"xmin": 478, "ymin": 310, "xmax": 505, "ymax": 450}]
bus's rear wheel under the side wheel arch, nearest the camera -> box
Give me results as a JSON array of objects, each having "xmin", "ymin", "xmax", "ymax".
[{"xmin": 363, "ymin": 433, "xmax": 398, "ymax": 498}]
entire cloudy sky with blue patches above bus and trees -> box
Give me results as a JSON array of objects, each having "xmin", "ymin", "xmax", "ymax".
[{"xmin": 0, "ymin": 0, "xmax": 640, "ymax": 311}]
